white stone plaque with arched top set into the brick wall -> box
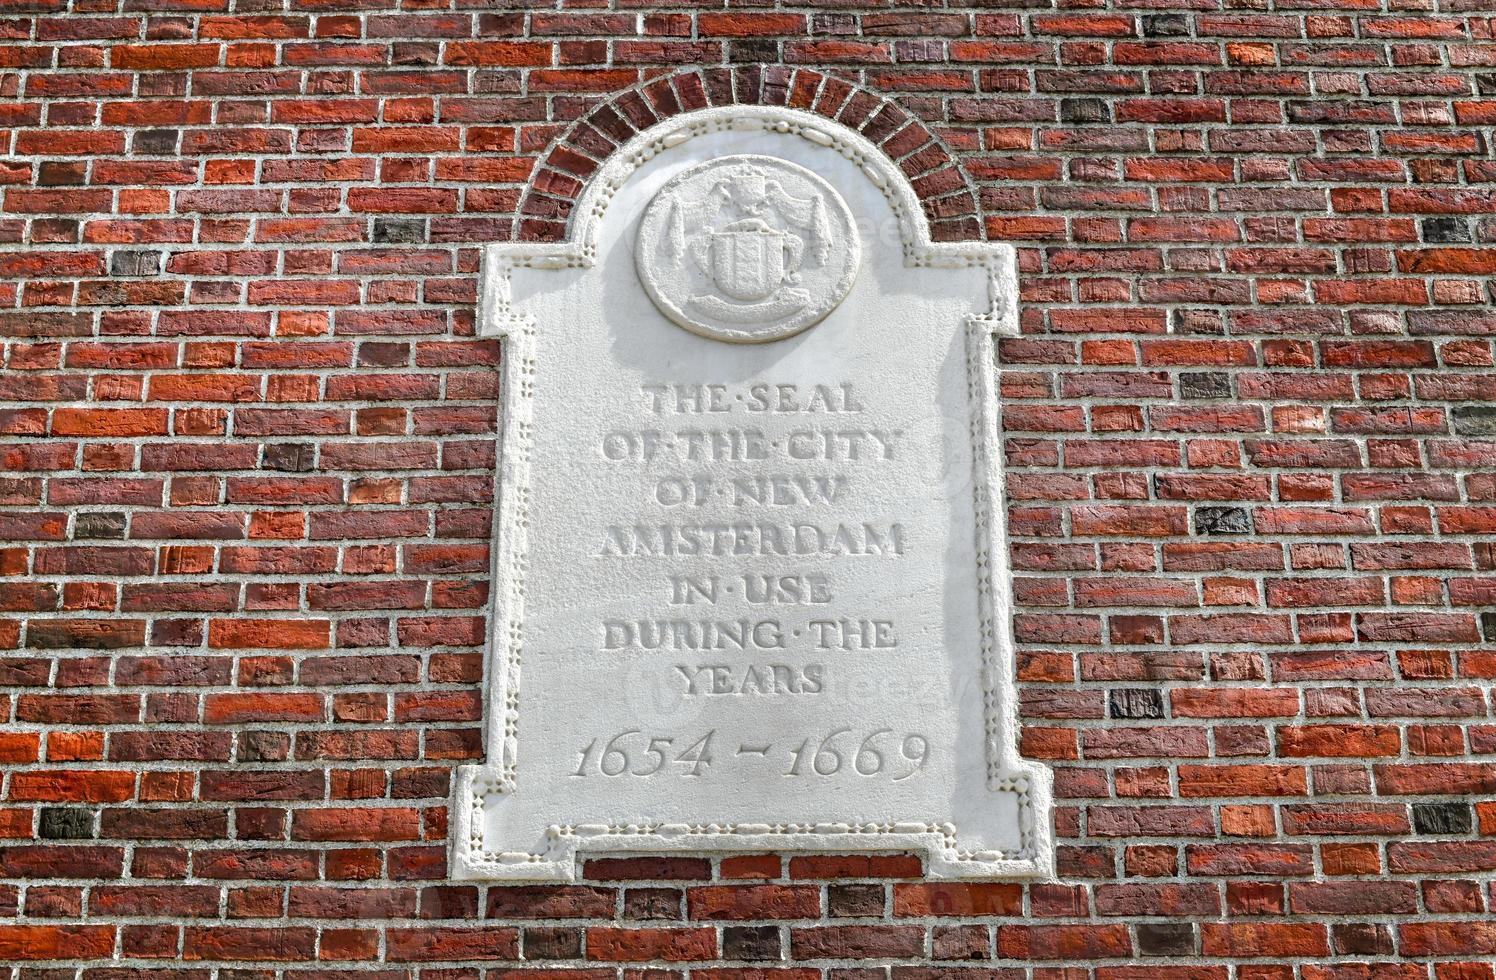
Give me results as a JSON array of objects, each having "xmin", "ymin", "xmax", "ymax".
[{"xmin": 452, "ymin": 106, "xmax": 1052, "ymax": 880}]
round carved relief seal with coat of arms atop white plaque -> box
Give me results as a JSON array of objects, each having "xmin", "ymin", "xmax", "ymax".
[{"xmin": 634, "ymin": 154, "xmax": 862, "ymax": 344}]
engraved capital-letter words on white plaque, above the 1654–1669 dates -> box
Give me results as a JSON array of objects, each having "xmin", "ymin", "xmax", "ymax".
[{"xmin": 595, "ymin": 375, "xmax": 914, "ymax": 712}]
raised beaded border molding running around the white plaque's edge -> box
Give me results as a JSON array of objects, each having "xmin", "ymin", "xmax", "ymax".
[{"xmin": 450, "ymin": 106, "xmax": 1053, "ymax": 881}]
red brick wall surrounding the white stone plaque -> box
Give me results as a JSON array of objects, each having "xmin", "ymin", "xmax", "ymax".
[{"xmin": 0, "ymin": 0, "xmax": 1496, "ymax": 980}]
